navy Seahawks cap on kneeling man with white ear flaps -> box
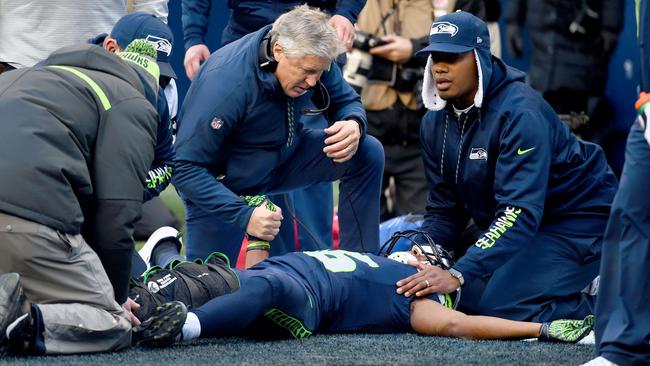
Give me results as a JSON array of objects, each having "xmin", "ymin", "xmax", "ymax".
[{"xmin": 417, "ymin": 10, "xmax": 490, "ymax": 55}]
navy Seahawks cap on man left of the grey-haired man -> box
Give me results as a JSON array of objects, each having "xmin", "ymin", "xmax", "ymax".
[{"xmin": 111, "ymin": 11, "xmax": 176, "ymax": 78}]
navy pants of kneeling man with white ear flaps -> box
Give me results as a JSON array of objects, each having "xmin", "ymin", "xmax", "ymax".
[{"xmin": 461, "ymin": 224, "xmax": 607, "ymax": 322}]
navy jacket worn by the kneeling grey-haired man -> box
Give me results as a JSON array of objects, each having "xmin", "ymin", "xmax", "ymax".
[{"xmin": 173, "ymin": 26, "xmax": 366, "ymax": 230}]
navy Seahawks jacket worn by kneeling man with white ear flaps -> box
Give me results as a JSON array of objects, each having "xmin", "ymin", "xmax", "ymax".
[{"xmin": 420, "ymin": 50, "xmax": 617, "ymax": 281}]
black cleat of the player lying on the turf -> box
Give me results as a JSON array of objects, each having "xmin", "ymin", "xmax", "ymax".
[{"xmin": 131, "ymin": 301, "xmax": 187, "ymax": 347}]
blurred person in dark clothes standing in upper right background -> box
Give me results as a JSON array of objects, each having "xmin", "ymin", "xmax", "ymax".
[{"xmin": 504, "ymin": 0, "xmax": 625, "ymax": 144}]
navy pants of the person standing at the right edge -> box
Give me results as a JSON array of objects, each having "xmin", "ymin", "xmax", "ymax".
[{"xmin": 596, "ymin": 123, "xmax": 650, "ymax": 365}]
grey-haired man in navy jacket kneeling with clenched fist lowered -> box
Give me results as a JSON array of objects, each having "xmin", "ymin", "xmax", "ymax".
[{"xmin": 173, "ymin": 6, "xmax": 384, "ymax": 266}]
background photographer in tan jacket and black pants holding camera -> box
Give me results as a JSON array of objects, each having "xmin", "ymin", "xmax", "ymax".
[{"xmin": 344, "ymin": 0, "xmax": 485, "ymax": 221}]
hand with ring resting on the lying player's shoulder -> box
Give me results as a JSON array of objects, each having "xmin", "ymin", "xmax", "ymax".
[{"xmin": 397, "ymin": 266, "xmax": 460, "ymax": 297}]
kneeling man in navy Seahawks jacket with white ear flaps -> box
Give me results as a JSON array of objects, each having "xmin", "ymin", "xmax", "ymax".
[{"xmin": 398, "ymin": 12, "xmax": 617, "ymax": 321}]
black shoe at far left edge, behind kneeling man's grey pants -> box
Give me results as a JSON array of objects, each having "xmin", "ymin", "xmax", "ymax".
[{"xmin": 0, "ymin": 273, "xmax": 25, "ymax": 350}]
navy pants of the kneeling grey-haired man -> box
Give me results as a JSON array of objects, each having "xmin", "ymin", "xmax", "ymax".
[{"xmin": 184, "ymin": 129, "xmax": 384, "ymax": 263}]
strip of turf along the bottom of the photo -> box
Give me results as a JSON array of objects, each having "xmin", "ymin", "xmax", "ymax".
[{"xmin": 0, "ymin": 334, "xmax": 594, "ymax": 366}]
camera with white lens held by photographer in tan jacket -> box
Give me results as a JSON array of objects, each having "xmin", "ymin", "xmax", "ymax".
[{"xmin": 343, "ymin": 31, "xmax": 424, "ymax": 98}]
